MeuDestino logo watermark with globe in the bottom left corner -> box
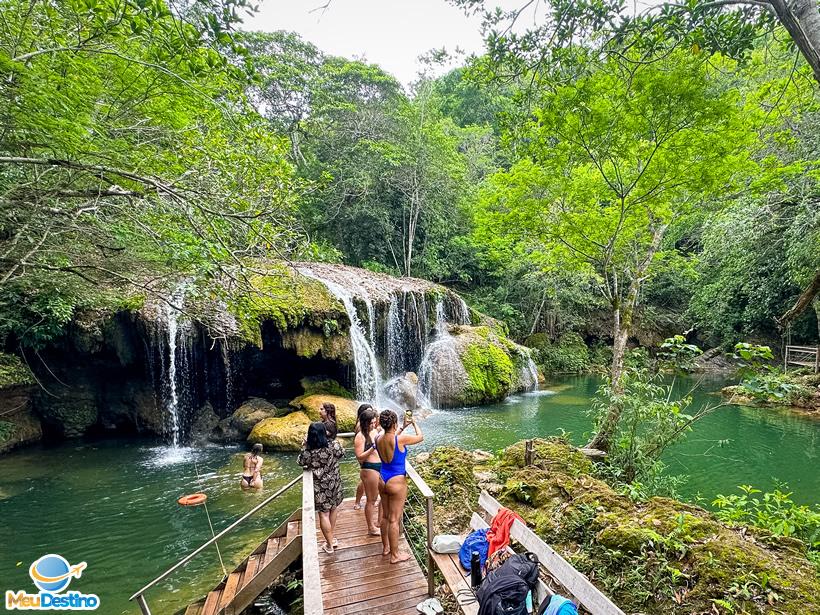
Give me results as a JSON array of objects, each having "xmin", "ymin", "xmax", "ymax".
[{"xmin": 6, "ymin": 553, "xmax": 100, "ymax": 611}]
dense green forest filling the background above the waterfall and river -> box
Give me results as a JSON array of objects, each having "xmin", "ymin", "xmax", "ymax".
[{"xmin": 0, "ymin": 0, "xmax": 820, "ymax": 356}]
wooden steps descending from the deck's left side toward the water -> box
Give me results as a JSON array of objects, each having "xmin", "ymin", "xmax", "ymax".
[{"xmin": 184, "ymin": 513, "xmax": 302, "ymax": 615}]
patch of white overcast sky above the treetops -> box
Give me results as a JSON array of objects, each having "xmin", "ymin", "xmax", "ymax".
[{"xmin": 244, "ymin": 0, "xmax": 520, "ymax": 85}]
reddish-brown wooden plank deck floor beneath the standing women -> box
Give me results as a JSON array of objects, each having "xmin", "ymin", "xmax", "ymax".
[{"xmin": 316, "ymin": 499, "xmax": 427, "ymax": 615}]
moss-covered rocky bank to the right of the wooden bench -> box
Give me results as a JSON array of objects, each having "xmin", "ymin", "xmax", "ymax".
[{"xmin": 416, "ymin": 440, "xmax": 820, "ymax": 615}]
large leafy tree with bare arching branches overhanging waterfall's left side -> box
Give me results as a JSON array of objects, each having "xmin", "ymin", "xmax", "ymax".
[{"xmin": 0, "ymin": 0, "xmax": 303, "ymax": 346}]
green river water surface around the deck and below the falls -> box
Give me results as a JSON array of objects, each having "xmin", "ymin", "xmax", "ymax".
[{"xmin": 0, "ymin": 377, "xmax": 820, "ymax": 615}]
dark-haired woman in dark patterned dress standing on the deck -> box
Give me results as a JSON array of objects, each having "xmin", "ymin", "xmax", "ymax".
[{"xmin": 297, "ymin": 421, "xmax": 344, "ymax": 553}]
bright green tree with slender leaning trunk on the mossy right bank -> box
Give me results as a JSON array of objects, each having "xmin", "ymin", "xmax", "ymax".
[{"xmin": 479, "ymin": 52, "xmax": 755, "ymax": 449}]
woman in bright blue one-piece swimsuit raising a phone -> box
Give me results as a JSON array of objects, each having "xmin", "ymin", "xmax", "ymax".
[{"xmin": 376, "ymin": 410, "xmax": 424, "ymax": 564}]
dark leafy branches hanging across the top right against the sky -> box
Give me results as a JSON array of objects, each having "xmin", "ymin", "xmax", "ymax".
[{"xmin": 451, "ymin": 0, "xmax": 820, "ymax": 81}]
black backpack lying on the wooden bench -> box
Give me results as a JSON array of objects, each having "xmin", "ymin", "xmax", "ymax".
[{"xmin": 476, "ymin": 553, "xmax": 538, "ymax": 615}]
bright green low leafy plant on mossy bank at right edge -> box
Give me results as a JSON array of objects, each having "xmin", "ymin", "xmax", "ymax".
[{"xmin": 712, "ymin": 485, "xmax": 820, "ymax": 555}]
